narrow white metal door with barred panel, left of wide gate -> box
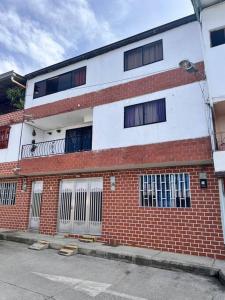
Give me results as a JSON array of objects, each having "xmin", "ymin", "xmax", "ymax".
[{"xmin": 30, "ymin": 181, "xmax": 43, "ymax": 230}]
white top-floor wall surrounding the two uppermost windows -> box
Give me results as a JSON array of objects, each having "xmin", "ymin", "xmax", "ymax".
[{"xmin": 25, "ymin": 22, "xmax": 202, "ymax": 108}]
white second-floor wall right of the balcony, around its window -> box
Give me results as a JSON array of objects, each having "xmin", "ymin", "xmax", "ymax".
[{"xmin": 93, "ymin": 83, "xmax": 209, "ymax": 150}]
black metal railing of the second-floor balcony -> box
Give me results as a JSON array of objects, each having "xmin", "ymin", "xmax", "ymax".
[{"xmin": 22, "ymin": 139, "xmax": 65, "ymax": 158}]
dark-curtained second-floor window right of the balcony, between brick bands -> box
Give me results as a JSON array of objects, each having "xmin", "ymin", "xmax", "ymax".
[{"xmin": 124, "ymin": 99, "xmax": 166, "ymax": 128}]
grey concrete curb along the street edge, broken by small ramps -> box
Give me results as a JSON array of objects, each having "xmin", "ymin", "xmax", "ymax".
[{"xmin": 0, "ymin": 233, "xmax": 225, "ymax": 286}]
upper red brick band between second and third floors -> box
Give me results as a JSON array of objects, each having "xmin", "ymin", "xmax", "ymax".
[{"xmin": 0, "ymin": 62, "xmax": 204, "ymax": 125}]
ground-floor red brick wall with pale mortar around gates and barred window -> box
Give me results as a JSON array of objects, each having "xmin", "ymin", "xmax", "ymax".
[{"xmin": 0, "ymin": 165, "xmax": 225, "ymax": 259}]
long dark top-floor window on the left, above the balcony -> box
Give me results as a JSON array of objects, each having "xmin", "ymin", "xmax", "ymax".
[{"xmin": 34, "ymin": 67, "xmax": 86, "ymax": 98}]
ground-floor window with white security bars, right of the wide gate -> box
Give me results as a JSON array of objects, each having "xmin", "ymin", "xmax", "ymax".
[{"xmin": 140, "ymin": 173, "xmax": 191, "ymax": 208}]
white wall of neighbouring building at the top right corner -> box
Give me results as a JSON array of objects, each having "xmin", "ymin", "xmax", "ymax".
[{"xmin": 201, "ymin": 2, "xmax": 225, "ymax": 102}]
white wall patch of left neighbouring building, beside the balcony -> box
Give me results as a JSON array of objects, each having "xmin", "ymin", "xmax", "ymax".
[{"xmin": 0, "ymin": 124, "xmax": 22, "ymax": 163}]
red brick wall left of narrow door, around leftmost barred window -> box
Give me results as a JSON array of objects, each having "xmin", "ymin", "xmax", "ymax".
[{"xmin": 0, "ymin": 178, "xmax": 31, "ymax": 230}]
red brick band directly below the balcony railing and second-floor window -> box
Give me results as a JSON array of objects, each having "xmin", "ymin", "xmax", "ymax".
[{"xmin": 20, "ymin": 137, "xmax": 211, "ymax": 175}]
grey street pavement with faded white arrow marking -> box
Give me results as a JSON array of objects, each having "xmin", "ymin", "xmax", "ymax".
[{"xmin": 0, "ymin": 241, "xmax": 225, "ymax": 300}]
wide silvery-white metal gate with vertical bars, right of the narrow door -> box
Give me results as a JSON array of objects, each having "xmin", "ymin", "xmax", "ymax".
[{"xmin": 58, "ymin": 178, "xmax": 103, "ymax": 235}]
